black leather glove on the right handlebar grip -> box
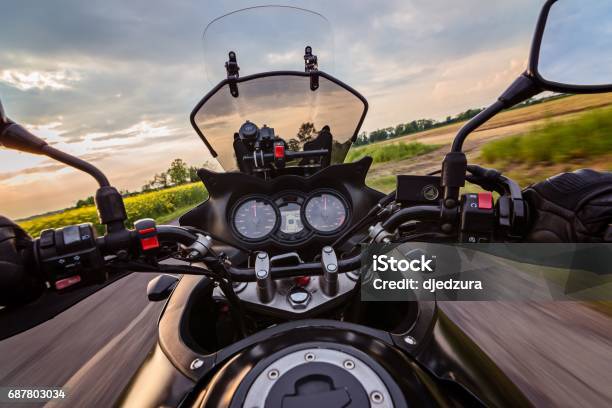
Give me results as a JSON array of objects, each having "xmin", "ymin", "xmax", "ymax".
[{"xmin": 523, "ymin": 169, "xmax": 612, "ymax": 242}]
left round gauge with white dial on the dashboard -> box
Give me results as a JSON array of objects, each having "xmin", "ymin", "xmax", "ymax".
[{"xmin": 232, "ymin": 198, "xmax": 278, "ymax": 240}]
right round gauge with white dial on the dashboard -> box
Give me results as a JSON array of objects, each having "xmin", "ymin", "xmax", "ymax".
[{"xmin": 304, "ymin": 192, "xmax": 348, "ymax": 233}]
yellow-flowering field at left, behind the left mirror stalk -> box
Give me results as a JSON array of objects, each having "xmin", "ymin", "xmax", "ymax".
[{"xmin": 18, "ymin": 183, "xmax": 208, "ymax": 237}]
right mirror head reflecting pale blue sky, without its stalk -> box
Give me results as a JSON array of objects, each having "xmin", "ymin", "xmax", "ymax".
[{"xmin": 528, "ymin": 0, "xmax": 612, "ymax": 93}]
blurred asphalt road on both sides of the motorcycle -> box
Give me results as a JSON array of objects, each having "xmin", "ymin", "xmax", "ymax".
[{"xmin": 0, "ymin": 274, "xmax": 612, "ymax": 407}]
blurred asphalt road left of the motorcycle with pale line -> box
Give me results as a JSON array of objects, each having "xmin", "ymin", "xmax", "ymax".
[{"xmin": 0, "ymin": 273, "xmax": 162, "ymax": 407}]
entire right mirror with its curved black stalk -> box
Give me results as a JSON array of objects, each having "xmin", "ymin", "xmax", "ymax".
[{"xmin": 442, "ymin": 0, "xmax": 612, "ymax": 208}]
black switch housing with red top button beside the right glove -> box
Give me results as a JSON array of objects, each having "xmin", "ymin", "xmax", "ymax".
[{"xmin": 460, "ymin": 192, "xmax": 497, "ymax": 243}]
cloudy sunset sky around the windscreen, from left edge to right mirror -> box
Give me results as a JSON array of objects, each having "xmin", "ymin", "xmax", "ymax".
[{"xmin": 0, "ymin": 0, "xmax": 542, "ymax": 218}]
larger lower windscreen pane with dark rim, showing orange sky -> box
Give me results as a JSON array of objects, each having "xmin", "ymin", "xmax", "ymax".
[{"xmin": 194, "ymin": 72, "xmax": 365, "ymax": 171}]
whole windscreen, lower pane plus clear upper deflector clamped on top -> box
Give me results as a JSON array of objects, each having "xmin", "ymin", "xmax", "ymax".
[{"xmin": 193, "ymin": 6, "xmax": 365, "ymax": 171}]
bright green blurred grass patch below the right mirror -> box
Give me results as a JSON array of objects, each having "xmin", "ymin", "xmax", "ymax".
[{"xmin": 481, "ymin": 108, "xmax": 612, "ymax": 167}]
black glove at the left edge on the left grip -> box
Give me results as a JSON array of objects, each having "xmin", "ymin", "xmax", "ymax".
[{"xmin": 0, "ymin": 216, "xmax": 45, "ymax": 306}]
